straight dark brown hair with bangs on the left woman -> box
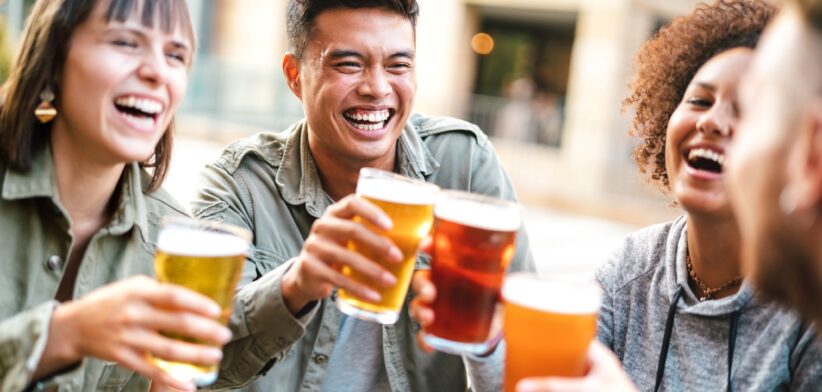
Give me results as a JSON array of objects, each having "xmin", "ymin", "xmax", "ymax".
[{"xmin": 0, "ymin": 0, "xmax": 195, "ymax": 191}]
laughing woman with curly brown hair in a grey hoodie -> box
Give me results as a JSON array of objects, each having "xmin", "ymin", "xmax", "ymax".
[{"xmin": 412, "ymin": 0, "xmax": 822, "ymax": 391}]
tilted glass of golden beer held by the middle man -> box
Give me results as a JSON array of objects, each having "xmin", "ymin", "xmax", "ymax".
[{"xmin": 337, "ymin": 168, "xmax": 439, "ymax": 324}]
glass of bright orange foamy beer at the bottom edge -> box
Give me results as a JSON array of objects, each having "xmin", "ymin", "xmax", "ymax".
[{"xmin": 502, "ymin": 273, "xmax": 602, "ymax": 392}]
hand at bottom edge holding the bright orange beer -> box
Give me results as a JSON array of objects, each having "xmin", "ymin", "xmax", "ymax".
[{"xmin": 517, "ymin": 341, "xmax": 637, "ymax": 392}]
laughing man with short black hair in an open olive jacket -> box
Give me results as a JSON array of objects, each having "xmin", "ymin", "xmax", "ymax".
[{"xmin": 194, "ymin": 0, "xmax": 534, "ymax": 391}]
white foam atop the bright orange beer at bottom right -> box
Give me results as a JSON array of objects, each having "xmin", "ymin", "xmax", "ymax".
[{"xmin": 502, "ymin": 273, "xmax": 602, "ymax": 314}]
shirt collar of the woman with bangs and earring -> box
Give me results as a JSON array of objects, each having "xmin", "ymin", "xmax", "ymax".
[{"xmin": 2, "ymin": 145, "xmax": 148, "ymax": 238}]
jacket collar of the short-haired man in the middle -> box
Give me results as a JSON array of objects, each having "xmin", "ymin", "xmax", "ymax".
[{"xmin": 275, "ymin": 118, "xmax": 439, "ymax": 218}]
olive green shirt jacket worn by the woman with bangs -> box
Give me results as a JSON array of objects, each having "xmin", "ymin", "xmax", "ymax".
[{"xmin": 0, "ymin": 148, "xmax": 185, "ymax": 392}]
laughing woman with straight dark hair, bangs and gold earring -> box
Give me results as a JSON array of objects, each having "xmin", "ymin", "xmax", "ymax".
[{"xmin": 0, "ymin": 0, "xmax": 230, "ymax": 391}]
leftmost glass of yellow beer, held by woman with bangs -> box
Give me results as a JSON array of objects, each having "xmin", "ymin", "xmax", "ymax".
[{"xmin": 152, "ymin": 218, "xmax": 251, "ymax": 386}]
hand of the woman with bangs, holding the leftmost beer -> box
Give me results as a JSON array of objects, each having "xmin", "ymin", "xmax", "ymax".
[{"xmin": 35, "ymin": 276, "xmax": 231, "ymax": 390}]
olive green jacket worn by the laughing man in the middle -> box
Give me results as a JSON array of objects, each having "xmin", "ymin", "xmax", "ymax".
[{"xmin": 192, "ymin": 115, "xmax": 534, "ymax": 391}]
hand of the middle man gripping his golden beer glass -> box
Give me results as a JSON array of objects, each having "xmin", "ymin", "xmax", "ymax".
[{"xmin": 282, "ymin": 195, "xmax": 402, "ymax": 314}]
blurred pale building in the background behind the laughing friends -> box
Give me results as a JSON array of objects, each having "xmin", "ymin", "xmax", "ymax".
[{"xmin": 0, "ymin": 0, "xmax": 708, "ymax": 276}]
